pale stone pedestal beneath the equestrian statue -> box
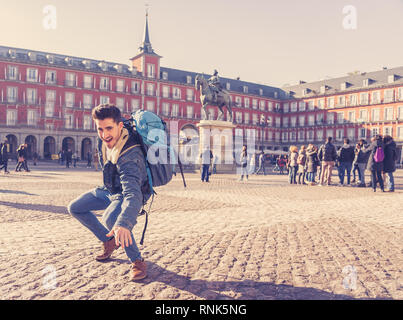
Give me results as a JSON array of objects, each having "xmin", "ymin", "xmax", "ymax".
[{"xmin": 197, "ymin": 120, "xmax": 236, "ymax": 173}]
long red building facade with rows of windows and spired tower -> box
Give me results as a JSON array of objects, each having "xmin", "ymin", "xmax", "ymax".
[{"xmin": 0, "ymin": 17, "xmax": 403, "ymax": 162}]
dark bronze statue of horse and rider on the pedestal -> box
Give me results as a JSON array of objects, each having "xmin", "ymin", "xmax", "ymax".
[{"xmin": 195, "ymin": 70, "xmax": 232, "ymax": 123}]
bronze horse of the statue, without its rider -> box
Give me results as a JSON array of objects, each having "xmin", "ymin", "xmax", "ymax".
[{"xmin": 195, "ymin": 74, "xmax": 233, "ymax": 123}]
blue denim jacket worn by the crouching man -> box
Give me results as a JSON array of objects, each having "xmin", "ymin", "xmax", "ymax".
[{"xmin": 98, "ymin": 138, "xmax": 151, "ymax": 230}]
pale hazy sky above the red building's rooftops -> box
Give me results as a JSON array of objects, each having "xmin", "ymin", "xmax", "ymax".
[{"xmin": 0, "ymin": 0, "xmax": 403, "ymax": 87}]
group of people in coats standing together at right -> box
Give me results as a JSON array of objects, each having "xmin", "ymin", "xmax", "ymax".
[{"xmin": 287, "ymin": 135, "xmax": 397, "ymax": 192}]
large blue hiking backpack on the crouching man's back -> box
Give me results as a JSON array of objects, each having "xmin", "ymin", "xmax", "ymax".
[{"xmin": 123, "ymin": 110, "xmax": 186, "ymax": 244}]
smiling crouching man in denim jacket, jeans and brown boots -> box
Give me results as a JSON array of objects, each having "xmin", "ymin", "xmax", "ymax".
[{"xmin": 68, "ymin": 104, "xmax": 152, "ymax": 281}]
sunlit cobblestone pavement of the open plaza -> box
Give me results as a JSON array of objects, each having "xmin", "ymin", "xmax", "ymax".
[{"xmin": 0, "ymin": 167, "xmax": 403, "ymax": 299}]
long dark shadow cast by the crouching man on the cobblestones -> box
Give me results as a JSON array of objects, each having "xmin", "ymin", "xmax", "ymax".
[{"xmin": 136, "ymin": 262, "xmax": 390, "ymax": 300}]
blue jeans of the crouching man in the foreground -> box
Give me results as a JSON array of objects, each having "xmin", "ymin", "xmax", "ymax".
[{"xmin": 68, "ymin": 188, "xmax": 141, "ymax": 262}]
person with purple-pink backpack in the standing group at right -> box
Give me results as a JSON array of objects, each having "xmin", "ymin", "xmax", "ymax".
[{"xmin": 363, "ymin": 135, "xmax": 385, "ymax": 192}]
